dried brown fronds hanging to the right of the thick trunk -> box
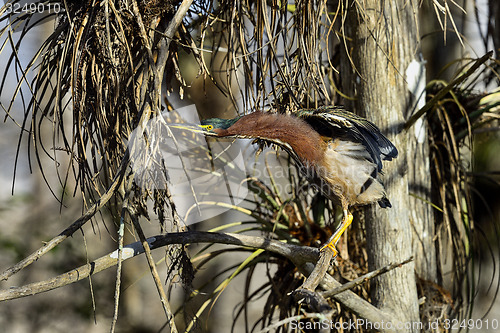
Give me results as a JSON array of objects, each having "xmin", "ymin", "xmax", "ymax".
[{"xmin": 422, "ymin": 54, "xmax": 500, "ymax": 321}]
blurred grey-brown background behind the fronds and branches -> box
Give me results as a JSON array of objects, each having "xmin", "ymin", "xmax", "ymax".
[{"xmin": 0, "ymin": 0, "xmax": 500, "ymax": 332}]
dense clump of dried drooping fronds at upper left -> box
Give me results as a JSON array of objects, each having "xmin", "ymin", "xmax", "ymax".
[{"xmin": 0, "ymin": 1, "xmax": 183, "ymax": 219}]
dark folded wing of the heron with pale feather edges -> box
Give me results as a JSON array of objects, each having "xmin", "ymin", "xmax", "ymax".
[{"xmin": 296, "ymin": 106, "xmax": 398, "ymax": 171}]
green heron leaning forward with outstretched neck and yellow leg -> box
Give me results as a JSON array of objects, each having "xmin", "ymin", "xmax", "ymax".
[{"xmin": 181, "ymin": 106, "xmax": 398, "ymax": 256}]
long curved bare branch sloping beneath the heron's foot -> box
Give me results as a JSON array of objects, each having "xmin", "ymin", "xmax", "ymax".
[{"xmin": 0, "ymin": 231, "xmax": 406, "ymax": 331}]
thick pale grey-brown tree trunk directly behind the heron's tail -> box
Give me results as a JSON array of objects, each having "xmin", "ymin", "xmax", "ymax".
[{"xmin": 341, "ymin": 0, "xmax": 436, "ymax": 332}]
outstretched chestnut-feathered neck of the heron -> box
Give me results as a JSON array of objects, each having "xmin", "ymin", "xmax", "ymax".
[{"xmin": 213, "ymin": 112, "xmax": 324, "ymax": 166}]
